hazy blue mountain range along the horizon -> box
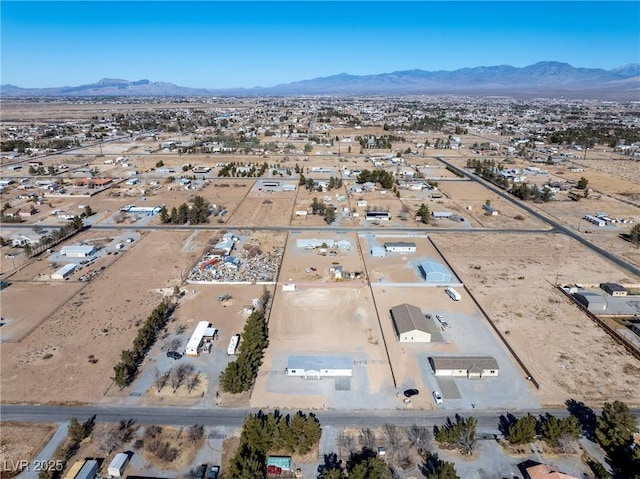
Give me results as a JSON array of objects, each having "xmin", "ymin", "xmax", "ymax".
[{"xmin": 0, "ymin": 61, "xmax": 640, "ymax": 101}]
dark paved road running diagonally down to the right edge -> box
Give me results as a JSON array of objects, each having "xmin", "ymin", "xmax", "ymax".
[{"xmin": 436, "ymin": 156, "xmax": 640, "ymax": 276}]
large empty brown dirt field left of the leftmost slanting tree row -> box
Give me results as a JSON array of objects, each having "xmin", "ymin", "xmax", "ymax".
[{"xmin": 1, "ymin": 232, "xmax": 204, "ymax": 403}]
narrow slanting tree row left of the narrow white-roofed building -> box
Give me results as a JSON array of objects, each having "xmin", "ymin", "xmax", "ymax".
[{"xmin": 113, "ymin": 298, "xmax": 175, "ymax": 389}]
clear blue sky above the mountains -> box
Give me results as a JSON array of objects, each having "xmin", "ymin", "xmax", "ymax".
[{"xmin": 0, "ymin": 0, "xmax": 640, "ymax": 88}]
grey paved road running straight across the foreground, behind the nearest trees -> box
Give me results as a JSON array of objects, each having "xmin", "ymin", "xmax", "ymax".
[{"xmin": 0, "ymin": 404, "xmax": 640, "ymax": 432}]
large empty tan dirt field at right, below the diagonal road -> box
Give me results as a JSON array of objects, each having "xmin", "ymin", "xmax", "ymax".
[{"xmin": 431, "ymin": 234, "xmax": 640, "ymax": 406}]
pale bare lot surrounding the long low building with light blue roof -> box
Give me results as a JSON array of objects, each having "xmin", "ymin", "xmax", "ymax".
[{"xmin": 251, "ymin": 285, "xmax": 393, "ymax": 409}]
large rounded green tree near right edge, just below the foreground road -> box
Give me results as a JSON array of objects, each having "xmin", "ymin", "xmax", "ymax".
[{"xmin": 595, "ymin": 401, "xmax": 638, "ymax": 451}]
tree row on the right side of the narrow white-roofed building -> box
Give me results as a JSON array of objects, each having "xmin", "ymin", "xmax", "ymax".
[{"xmin": 220, "ymin": 289, "xmax": 270, "ymax": 394}]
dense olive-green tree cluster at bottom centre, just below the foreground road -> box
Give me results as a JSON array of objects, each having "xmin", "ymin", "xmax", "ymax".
[{"xmin": 226, "ymin": 411, "xmax": 322, "ymax": 479}]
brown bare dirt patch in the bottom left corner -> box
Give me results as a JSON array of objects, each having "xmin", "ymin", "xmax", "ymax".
[{"xmin": 0, "ymin": 422, "xmax": 56, "ymax": 479}]
